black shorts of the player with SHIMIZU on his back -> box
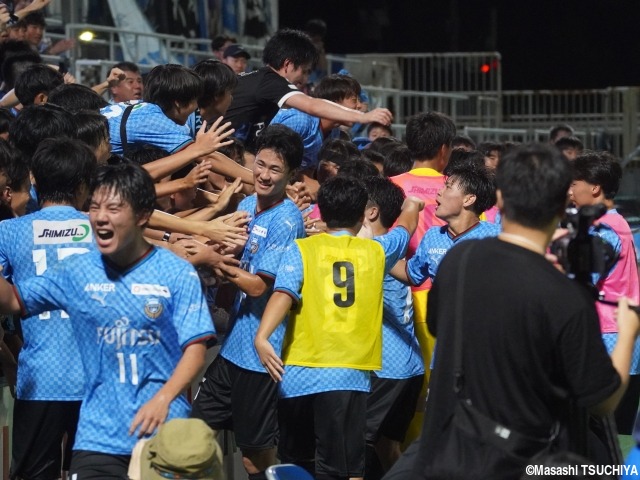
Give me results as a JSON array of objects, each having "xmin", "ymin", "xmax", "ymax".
[{"xmin": 11, "ymin": 399, "xmax": 81, "ymax": 480}]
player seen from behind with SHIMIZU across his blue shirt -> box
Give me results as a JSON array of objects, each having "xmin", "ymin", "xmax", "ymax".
[{"xmin": 0, "ymin": 139, "xmax": 96, "ymax": 479}]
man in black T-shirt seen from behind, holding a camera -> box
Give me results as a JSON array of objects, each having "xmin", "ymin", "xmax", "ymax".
[{"xmin": 385, "ymin": 144, "xmax": 640, "ymax": 480}]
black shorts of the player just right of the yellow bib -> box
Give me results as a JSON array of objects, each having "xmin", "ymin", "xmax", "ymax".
[{"xmin": 367, "ymin": 374, "xmax": 424, "ymax": 443}]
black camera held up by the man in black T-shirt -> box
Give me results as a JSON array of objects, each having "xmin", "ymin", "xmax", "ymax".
[{"xmin": 551, "ymin": 204, "xmax": 618, "ymax": 288}]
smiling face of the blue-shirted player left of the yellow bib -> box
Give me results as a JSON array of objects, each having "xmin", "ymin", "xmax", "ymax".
[{"xmin": 253, "ymin": 148, "xmax": 290, "ymax": 209}]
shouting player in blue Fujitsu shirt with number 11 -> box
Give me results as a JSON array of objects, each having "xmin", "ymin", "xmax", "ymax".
[{"xmin": 0, "ymin": 164, "xmax": 214, "ymax": 480}]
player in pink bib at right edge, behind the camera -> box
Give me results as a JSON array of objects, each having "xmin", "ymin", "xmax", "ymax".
[{"xmin": 569, "ymin": 151, "xmax": 640, "ymax": 435}]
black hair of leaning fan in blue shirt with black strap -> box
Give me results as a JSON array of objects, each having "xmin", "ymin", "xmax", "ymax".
[{"xmin": 143, "ymin": 63, "xmax": 203, "ymax": 113}]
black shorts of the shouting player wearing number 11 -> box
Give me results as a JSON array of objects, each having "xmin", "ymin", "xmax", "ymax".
[{"xmin": 69, "ymin": 450, "xmax": 131, "ymax": 480}]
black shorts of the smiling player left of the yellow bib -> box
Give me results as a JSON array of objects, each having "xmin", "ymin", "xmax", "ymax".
[{"xmin": 191, "ymin": 355, "xmax": 278, "ymax": 450}]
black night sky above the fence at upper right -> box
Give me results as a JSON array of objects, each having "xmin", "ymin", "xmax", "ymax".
[{"xmin": 280, "ymin": 0, "xmax": 640, "ymax": 90}]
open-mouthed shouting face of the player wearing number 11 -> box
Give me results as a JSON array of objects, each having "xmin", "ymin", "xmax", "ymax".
[{"xmin": 89, "ymin": 187, "xmax": 149, "ymax": 266}]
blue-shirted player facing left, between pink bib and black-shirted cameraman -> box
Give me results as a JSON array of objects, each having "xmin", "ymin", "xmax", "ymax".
[{"xmin": 393, "ymin": 159, "xmax": 500, "ymax": 285}]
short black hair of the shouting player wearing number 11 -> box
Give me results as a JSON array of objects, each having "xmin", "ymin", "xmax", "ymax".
[{"xmin": 89, "ymin": 162, "xmax": 156, "ymax": 215}]
